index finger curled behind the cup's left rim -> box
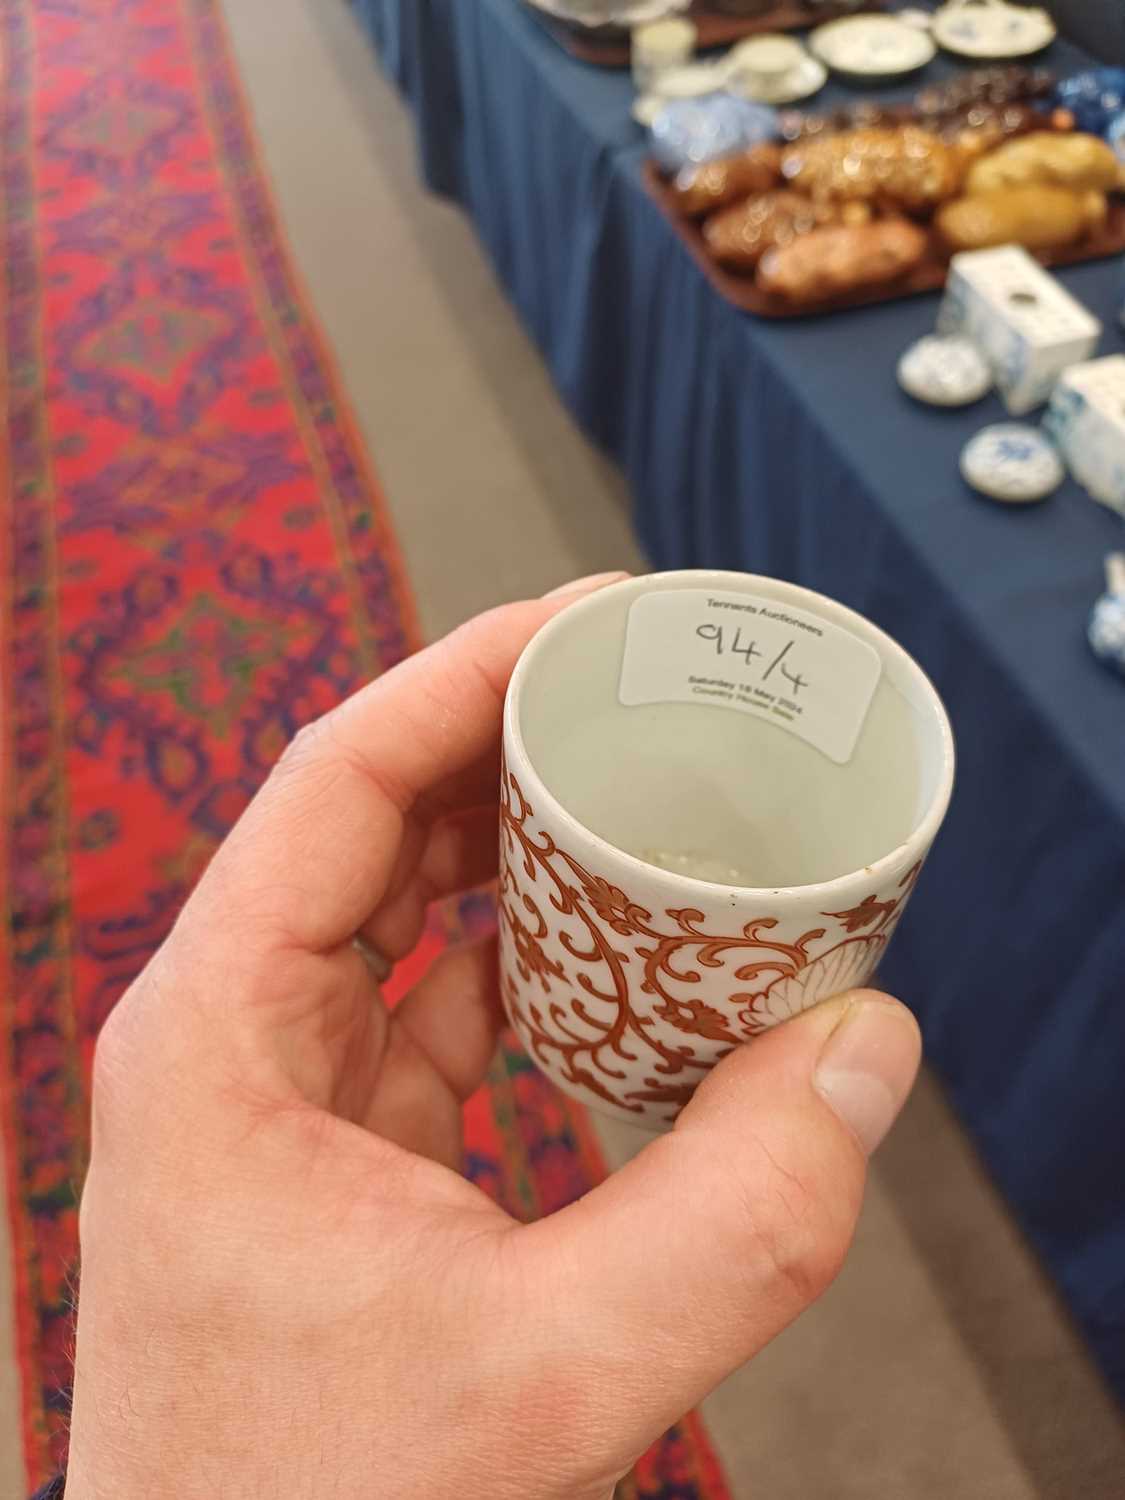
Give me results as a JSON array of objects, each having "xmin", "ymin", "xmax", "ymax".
[{"xmin": 185, "ymin": 573, "xmax": 627, "ymax": 951}]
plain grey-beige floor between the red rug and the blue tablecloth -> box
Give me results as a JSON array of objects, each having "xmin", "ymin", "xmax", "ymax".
[{"xmin": 0, "ymin": 0, "xmax": 1125, "ymax": 1500}]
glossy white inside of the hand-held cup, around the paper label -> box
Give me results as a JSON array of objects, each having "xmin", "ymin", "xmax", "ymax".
[{"xmin": 507, "ymin": 570, "xmax": 953, "ymax": 890}]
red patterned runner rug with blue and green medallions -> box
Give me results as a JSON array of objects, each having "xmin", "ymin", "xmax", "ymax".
[{"xmin": 0, "ymin": 0, "xmax": 726, "ymax": 1500}]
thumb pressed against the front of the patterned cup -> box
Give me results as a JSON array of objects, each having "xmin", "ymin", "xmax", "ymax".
[{"xmin": 527, "ymin": 990, "xmax": 921, "ymax": 1448}]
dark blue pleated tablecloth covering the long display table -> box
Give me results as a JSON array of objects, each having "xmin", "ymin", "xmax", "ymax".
[{"xmin": 357, "ymin": 0, "xmax": 1125, "ymax": 1395}]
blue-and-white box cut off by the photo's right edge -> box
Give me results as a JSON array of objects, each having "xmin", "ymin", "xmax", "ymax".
[{"xmin": 1044, "ymin": 354, "xmax": 1125, "ymax": 516}]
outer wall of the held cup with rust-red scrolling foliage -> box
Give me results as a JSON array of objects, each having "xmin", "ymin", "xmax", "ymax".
[{"xmin": 500, "ymin": 765, "xmax": 921, "ymax": 1119}]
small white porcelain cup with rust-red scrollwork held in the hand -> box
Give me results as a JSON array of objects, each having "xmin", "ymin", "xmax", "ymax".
[{"xmin": 500, "ymin": 570, "xmax": 954, "ymax": 1128}]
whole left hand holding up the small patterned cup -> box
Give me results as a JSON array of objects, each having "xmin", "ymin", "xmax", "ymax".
[{"xmin": 66, "ymin": 579, "xmax": 920, "ymax": 1500}]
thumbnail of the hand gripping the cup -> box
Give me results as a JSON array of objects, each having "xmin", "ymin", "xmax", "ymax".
[{"xmin": 813, "ymin": 1001, "xmax": 921, "ymax": 1157}]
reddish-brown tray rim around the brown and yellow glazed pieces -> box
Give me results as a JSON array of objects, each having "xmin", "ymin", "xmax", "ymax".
[{"xmin": 645, "ymin": 162, "xmax": 1125, "ymax": 318}]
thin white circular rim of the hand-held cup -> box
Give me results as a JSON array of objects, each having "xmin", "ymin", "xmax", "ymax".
[{"xmin": 503, "ymin": 569, "xmax": 957, "ymax": 903}]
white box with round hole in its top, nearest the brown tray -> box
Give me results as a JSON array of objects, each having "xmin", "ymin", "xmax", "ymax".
[{"xmin": 938, "ymin": 245, "xmax": 1101, "ymax": 417}]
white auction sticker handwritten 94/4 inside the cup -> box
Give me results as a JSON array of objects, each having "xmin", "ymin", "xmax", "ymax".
[{"xmin": 618, "ymin": 588, "xmax": 882, "ymax": 765}]
